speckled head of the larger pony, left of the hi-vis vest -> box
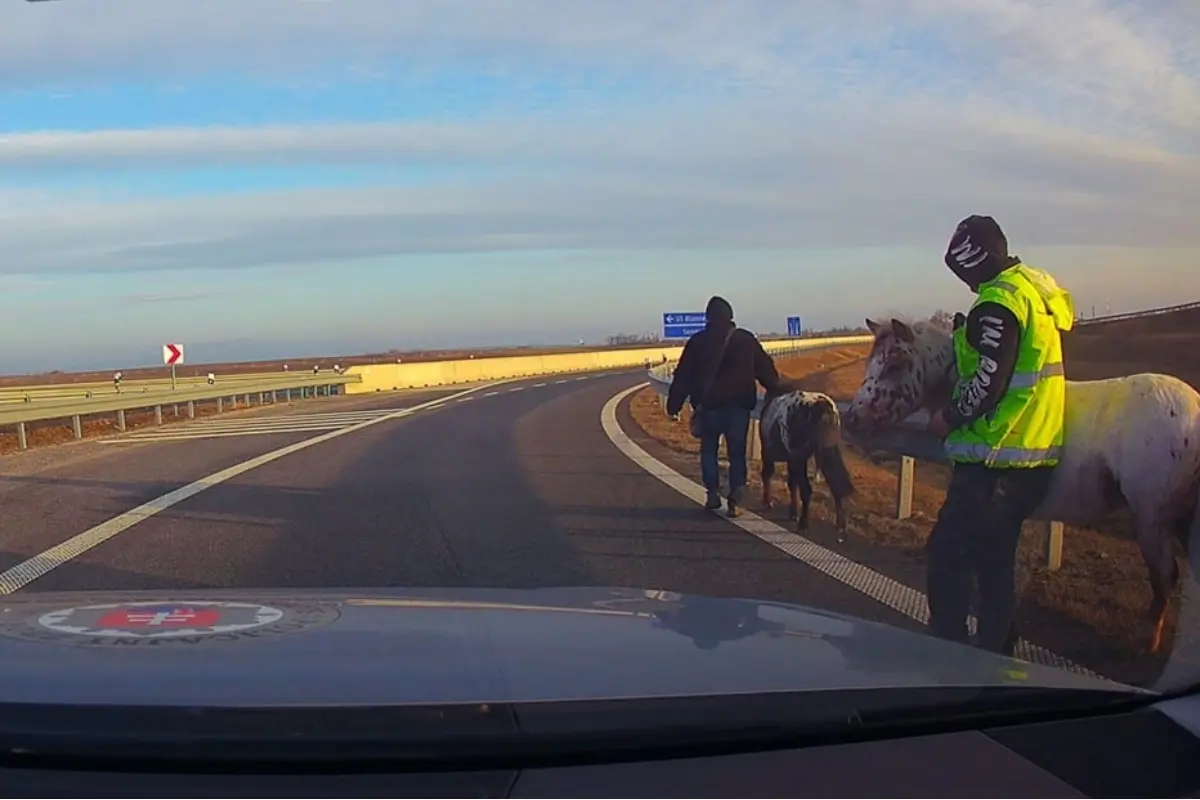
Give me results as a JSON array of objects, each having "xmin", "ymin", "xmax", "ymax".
[{"xmin": 844, "ymin": 319, "xmax": 954, "ymax": 435}]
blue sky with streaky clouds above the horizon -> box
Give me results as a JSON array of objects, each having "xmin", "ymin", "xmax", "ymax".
[{"xmin": 0, "ymin": 0, "xmax": 1200, "ymax": 372}]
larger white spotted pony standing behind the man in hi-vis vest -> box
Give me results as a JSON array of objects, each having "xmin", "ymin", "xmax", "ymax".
[{"xmin": 844, "ymin": 319, "xmax": 1200, "ymax": 652}]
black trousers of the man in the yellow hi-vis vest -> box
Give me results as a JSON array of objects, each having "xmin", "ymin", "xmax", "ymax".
[{"xmin": 925, "ymin": 464, "xmax": 1054, "ymax": 655}]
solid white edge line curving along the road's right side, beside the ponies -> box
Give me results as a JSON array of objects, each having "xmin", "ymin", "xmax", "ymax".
[{"xmin": 600, "ymin": 383, "xmax": 1108, "ymax": 680}]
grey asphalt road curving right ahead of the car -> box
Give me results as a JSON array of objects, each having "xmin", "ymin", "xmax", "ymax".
[{"xmin": 0, "ymin": 372, "xmax": 917, "ymax": 627}]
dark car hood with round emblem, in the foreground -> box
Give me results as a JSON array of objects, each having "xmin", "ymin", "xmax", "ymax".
[{"xmin": 0, "ymin": 588, "xmax": 1128, "ymax": 706}]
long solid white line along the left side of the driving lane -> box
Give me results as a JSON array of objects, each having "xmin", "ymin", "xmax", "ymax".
[{"xmin": 0, "ymin": 384, "xmax": 496, "ymax": 595}]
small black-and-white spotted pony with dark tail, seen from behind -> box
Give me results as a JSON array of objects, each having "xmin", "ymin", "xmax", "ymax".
[{"xmin": 758, "ymin": 384, "xmax": 854, "ymax": 541}]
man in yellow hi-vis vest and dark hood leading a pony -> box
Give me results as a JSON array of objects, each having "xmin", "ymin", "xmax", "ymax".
[{"xmin": 926, "ymin": 216, "xmax": 1075, "ymax": 655}]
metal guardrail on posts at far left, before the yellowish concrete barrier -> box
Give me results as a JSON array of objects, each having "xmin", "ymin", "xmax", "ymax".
[{"xmin": 0, "ymin": 373, "xmax": 362, "ymax": 450}]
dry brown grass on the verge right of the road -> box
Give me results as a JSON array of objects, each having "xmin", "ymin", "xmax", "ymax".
[{"xmin": 630, "ymin": 314, "xmax": 1200, "ymax": 682}]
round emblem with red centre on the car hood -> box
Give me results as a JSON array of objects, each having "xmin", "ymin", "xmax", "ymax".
[{"xmin": 0, "ymin": 600, "xmax": 338, "ymax": 645}]
